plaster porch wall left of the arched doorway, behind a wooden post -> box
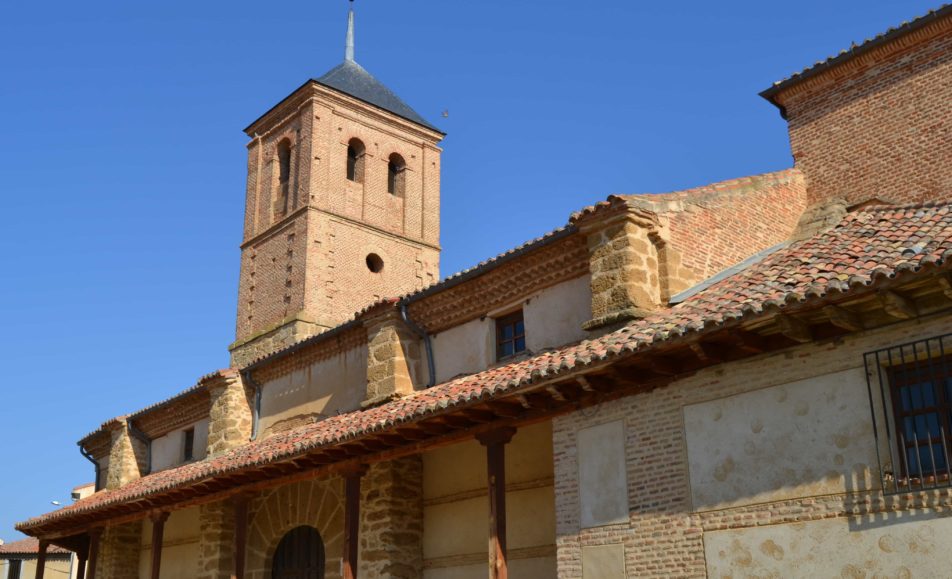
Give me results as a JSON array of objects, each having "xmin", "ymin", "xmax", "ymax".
[{"xmin": 139, "ymin": 507, "xmax": 201, "ymax": 579}]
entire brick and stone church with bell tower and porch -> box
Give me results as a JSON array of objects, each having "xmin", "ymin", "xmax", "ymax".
[{"xmin": 17, "ymin": 6, "xmax": 952, "ymax": 579}]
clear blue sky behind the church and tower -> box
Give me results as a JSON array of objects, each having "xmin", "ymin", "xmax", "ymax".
[{"xmin": 0, "ymin": 0, "xmax": 938, "ymax": 541}]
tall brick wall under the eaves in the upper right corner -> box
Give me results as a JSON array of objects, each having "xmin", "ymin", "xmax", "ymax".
[{"xmin": 777, "ymin": 17, "xmax": 952, "ymax": 204}]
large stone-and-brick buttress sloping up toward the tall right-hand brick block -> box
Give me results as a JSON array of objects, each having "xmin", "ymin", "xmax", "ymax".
[{"xmin": 574, "ymin": 169, "xmax": 806, "ymax": 330}]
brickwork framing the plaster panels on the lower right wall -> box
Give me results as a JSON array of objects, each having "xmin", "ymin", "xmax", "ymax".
[{"xmin": 553, "ymin": 315, "xmax": 952, "ymax": 579}]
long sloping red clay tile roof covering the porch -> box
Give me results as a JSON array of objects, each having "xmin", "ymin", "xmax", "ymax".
[{"xmin": 18, "ymin": 203, "xmax": 952, "ymax": 530}]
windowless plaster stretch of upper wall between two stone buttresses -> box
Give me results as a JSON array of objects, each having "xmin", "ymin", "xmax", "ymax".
[{"xmin": 260, "ymin": 346, "xmax": 367, "ymax": 436}]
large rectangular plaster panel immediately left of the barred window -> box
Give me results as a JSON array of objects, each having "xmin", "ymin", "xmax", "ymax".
[{"xmin": 684, "ymin": 368, "xmax": 879, "ymax": 510}]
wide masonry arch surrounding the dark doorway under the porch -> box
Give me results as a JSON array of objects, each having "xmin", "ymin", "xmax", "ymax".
[{"xmin": 246, "ymin": 478, "xmax": 344, "ymax": 579}]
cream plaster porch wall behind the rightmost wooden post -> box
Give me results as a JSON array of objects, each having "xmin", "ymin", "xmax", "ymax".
[{"xmin": 423, "ymin": 423, "xmax": 555, "ymax": 579}]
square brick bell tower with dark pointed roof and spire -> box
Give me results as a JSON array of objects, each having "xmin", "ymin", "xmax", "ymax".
[{"xmin": 229, "ymin": 5, "xmax": 444, "ymax": 367}]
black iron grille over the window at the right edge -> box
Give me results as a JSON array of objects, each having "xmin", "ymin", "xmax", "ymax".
[{"xmin": 864, "ymin": 334, "xmax": 952, "ymax": 494}]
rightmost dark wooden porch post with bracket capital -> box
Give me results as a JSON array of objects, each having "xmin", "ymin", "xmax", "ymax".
[{"xmin": 476, "ymin": 427, "xmax": 516, "ymax": 579}]
